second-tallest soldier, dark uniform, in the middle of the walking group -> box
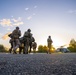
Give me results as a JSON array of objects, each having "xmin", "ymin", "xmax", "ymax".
[{"xmin": 23, "ymin": 29, "xmax": 32, "ymax": 54}]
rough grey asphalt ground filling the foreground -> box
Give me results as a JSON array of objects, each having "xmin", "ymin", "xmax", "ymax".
[{"xmin": 0, "ymin": 53, "xmax": 76, "ymax": 75}]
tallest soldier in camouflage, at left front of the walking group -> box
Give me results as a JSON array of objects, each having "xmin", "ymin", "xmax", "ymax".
[{"xmin": 12, "ymin": 27, "xmax": 21, "ymax": 54}]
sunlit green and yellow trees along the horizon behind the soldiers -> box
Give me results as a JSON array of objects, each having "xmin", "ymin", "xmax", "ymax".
[{"xmin": 0, "ymin": 39, "xmax": 76, "ymax": 53}]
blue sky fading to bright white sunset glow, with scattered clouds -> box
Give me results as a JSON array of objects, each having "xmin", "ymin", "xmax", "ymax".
[{"xmin": 0, "ymin": 0, "xmax": 76, "ymax": 47}]
